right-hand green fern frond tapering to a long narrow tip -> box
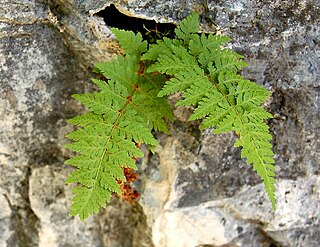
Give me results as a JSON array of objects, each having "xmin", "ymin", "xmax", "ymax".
[{"xmin": 143, "ymin": 15, "xmax": 275, "ymax": 208}]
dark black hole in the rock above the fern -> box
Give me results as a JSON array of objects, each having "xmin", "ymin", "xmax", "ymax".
[{"xmin": 96, "ymin": 4, "xmax": 176, "ymax": 43}]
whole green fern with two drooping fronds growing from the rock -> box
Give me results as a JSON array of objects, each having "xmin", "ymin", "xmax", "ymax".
[{"xmin": 66, "ymin": 13, "xmax": 275, "ymax": 220}]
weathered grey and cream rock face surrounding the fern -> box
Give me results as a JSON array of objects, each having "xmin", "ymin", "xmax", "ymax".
[{"xmin": 0, "ymin": 0, "xmax": 320, "ymax": 247}]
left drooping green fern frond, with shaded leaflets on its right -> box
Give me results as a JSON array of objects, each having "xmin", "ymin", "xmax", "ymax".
[{"xmin": 66, "ymin": 44, "xmax": 173, "ymax": 220}]
